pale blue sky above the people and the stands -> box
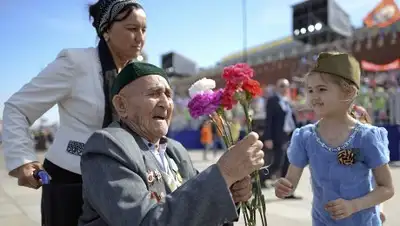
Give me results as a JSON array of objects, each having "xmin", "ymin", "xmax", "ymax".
[{"xmin": 0, "ymin": 0, "xmax": 394, "ymax": 125}]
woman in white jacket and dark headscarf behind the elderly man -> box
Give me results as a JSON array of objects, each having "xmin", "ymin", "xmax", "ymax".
[{"xmin": 3, "ymin": 0, "xmax": 146, "ymax": 226}]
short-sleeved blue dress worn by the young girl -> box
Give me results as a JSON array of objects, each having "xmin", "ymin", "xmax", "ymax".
[{"xmin": 288, "ymin": 123, "xmax": 389, "ymax": 226}]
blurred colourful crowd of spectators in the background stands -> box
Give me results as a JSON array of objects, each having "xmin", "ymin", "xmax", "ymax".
[{"xmin": 171, "ymin": 70, "xmax": 400, "ymax": 138}]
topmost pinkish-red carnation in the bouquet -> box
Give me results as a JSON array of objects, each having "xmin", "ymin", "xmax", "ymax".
[{"xmin": 222, "ymin": 63, "xmax": 254, "ymax": 85}]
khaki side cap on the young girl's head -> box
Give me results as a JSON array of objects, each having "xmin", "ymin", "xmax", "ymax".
[{"xmin": 311, "ymin": 52, "xmax": 361, "ymax": 88}]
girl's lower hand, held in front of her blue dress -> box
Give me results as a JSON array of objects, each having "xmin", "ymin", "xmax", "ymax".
[{"xmin": 325, "ymin": 199, "xmax": 356, "ymax": 220}]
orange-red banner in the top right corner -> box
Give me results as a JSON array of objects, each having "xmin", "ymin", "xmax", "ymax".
[{"xmin": 364, "ymin": 0, "xmax": 400, "ymax": 27}]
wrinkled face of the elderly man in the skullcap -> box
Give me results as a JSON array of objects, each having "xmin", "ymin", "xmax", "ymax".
[{"xmin": 120, "ymin": 75, "xmax": 174, "ymax": 141}]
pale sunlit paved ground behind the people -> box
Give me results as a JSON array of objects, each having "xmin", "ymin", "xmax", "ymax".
[{"xmin": 0, "ymin": 149, "xmax": 400, "ymax": 226}]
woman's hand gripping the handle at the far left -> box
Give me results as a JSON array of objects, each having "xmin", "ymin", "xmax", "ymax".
[{"xmin": 10, "ymin": 162, "xmax": 43, "ymax": 189}]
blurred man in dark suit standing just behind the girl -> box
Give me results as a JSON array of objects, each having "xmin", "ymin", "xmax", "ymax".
[{"xmin": 261, "ymin": 79, "xmax": 301, "ymax": 199}]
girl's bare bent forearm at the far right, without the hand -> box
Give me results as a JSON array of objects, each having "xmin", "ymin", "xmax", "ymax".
[{"xmin": 353, "ymin": 164, "xmax": 394, "ymax": 212}]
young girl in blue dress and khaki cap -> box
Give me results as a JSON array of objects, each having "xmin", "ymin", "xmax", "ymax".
[{"xmin": 275, "ymin": 53, "xmax": 394, "ymax": 226}]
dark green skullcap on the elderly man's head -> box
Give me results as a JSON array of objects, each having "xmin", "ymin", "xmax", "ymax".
[{"xmin": 111, "ymin": 62, "xmax": 169, "ymax": 97}]
